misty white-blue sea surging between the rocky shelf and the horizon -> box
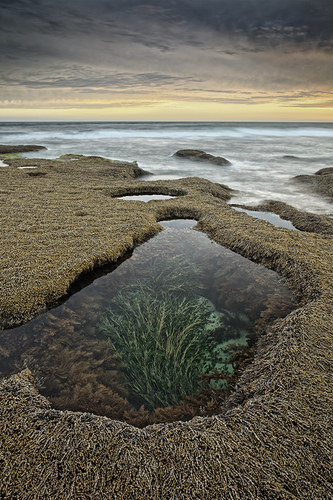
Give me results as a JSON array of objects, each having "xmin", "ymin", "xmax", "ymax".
[{"xmin": 0, "ymin": 122, "xmax": 333, "ymax": 214}]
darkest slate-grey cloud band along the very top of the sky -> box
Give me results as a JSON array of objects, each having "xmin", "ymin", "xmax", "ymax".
[{"xmin": 0, "ymin": 0, "xmax": 333, "ymax": 48}]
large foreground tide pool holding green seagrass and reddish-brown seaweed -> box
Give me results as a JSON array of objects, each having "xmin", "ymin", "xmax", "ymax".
[{"xmin": 0, "ymin": 220, "xmax": 295, "ymax": 425}]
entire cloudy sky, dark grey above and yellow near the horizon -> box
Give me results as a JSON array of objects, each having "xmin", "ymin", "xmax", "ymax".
[{"xmin": 0, "ymin": 0, "xmax": 333, "ymax": 121}]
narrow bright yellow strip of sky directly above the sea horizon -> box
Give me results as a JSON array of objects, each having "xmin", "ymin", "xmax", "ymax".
[{"xmin": 0, "ymin": 99, "xmax": 333, "ymax": 121}]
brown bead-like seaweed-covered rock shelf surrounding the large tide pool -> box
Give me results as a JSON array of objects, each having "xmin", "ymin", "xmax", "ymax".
[{"xmin": 0, "ymin": 157, "xmax": 333, "ymax": 500}]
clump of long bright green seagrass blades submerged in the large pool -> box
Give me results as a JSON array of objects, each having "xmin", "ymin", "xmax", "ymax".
[{"xmin": 98, "ymin": 289, "xmax": 217, "ymax": 409}]
